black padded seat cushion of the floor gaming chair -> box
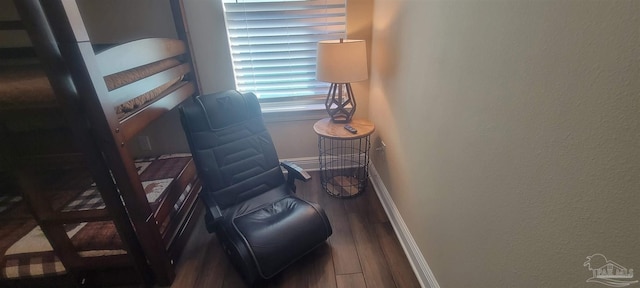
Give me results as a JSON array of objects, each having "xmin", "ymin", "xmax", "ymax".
[{"xmin": 223, "ymin": 184, "xmax": 331, "ymax": 278}]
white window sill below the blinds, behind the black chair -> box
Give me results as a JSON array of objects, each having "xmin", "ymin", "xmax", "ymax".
[{"xmin": 260, "ymin": 102, "xmax": 328, "ymax": 123}]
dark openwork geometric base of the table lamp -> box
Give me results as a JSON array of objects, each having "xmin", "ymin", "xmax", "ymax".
[{"xmin": 324, "ymin": 83, "xmax": 356, "ymax": 123}]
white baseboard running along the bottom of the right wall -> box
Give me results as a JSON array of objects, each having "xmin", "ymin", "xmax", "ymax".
[{"xmin": 369, "ymin": 164, "xmax": 440, "ymax": 288}]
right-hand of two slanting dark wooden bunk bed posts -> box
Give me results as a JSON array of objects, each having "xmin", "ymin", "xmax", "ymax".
[{"xmin": 42, "ymin": 0, "xmax": 175, "ymax": 285}]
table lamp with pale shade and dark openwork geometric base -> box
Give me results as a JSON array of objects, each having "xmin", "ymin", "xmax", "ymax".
[{"xmin": 316, "ymin": 39, "xmax": 368, "ymax": 123}]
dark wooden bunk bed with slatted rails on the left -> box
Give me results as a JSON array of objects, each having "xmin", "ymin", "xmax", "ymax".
[{"xmin": 0, "ymin": 0, "xmax": 201, "ymax": 286}]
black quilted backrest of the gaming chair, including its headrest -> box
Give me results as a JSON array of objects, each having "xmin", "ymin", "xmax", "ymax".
[{"xmin": 180, "ymin": 91, "xmax": 285, "ymax": 209}]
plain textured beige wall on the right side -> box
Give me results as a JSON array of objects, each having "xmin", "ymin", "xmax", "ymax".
[{"xmin": 369, "ymin": 0, "xmax": 640, "ymax": 287}]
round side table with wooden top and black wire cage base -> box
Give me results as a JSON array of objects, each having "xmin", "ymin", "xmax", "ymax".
[{"xmin": 313, "ymin": 118, "xmax": 375, "ymax": 198}]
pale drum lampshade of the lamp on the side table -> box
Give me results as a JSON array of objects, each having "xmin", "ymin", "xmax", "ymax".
[{"xmin": 316, "ymin": 39, "xmax": 369, "ymax": 83}]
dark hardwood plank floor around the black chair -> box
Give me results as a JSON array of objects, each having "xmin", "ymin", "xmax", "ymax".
[{"xmin": 171, "ymin": 172, "xmax": 420, "ymax": 288}]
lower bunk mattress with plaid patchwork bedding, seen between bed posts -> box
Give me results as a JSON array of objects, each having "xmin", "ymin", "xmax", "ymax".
[{"xmin": 0, "ymin": 154, "xmax": 195, "ymax": 279}]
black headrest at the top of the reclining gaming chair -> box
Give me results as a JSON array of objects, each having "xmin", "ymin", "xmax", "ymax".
[{"xmin": 196, "ymin": 90, "xmax": 262, "ymax": 129}]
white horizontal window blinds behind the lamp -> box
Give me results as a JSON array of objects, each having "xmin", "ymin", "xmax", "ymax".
[{"xmin": 222, "ymin": 0, "xmax": 346, "ymax": 99}]
